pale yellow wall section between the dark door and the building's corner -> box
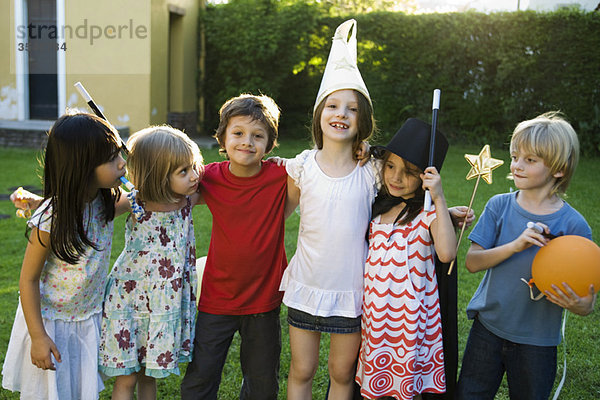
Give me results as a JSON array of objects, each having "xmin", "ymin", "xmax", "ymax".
[{"xmin": 65, "ymin": 0, "xmax": 152, "ymax": 132}]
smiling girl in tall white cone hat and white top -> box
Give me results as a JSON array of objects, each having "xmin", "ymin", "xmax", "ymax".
[{"xmin": 280, "ymin": 20, "xmax": 377, "ymax": 399}]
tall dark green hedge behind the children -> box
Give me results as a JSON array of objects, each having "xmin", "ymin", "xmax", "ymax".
[{"xmin": 202, "ymin": 4, "xmax": 600, "ymax": 155}]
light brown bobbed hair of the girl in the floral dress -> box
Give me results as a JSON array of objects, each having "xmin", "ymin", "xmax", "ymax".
[{"xmin": 127, "ymin": 125, "xmax": 204, "ymax": 203}]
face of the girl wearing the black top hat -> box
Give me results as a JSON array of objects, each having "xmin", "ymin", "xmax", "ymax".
[{"xmin": 383, "ymin": 153, "xmax": 422, "ymax": 199}]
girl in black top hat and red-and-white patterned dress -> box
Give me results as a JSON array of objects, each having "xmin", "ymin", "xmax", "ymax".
[{"xmin": 356, "ymin": 118, "xmax": 456, "ymax": 400}]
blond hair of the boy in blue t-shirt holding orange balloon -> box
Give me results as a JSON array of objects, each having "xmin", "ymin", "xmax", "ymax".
[{"xmin": 510, "ymin": 111, "xmax": 579, "ymax": 195}]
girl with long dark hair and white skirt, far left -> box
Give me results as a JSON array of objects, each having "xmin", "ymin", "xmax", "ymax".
[{"xmin": 2, "ymin": 113, "xmax": 129, "ymax": 400}]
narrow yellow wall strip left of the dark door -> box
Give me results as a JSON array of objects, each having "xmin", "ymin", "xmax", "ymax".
[{"xmin": 0, "ymin": 0, "xmax": 17, "ymax": 119}]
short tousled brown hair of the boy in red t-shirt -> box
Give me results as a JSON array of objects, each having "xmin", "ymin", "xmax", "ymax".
[{"xmin": 214, "ymin": 93, "xmax": 280, "ymax": 154}]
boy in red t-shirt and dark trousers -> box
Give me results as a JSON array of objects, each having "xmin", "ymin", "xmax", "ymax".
[{"xmin": 181, "ymin": 94, "xmax": 287, "ymax": 399}]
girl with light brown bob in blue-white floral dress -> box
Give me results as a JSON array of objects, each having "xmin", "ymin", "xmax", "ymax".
[{"xmin": 100, "ymin": 126, "xmax": 202, "ymax": 399}]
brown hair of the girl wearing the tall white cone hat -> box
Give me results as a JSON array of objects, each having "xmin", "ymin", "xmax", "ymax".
[{"xmin": 312, "ymin": 89, "xmax": 377, "ymax": 159}]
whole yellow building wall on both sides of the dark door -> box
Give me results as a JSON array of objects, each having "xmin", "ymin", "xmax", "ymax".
[{"xmin": 0, "ymin": 0, "xmax": 203, "ymax": 132}]
